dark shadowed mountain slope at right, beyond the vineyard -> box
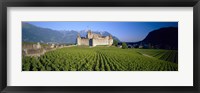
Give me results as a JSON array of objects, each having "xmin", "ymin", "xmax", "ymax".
[{"xmin": 142, "ymin": 27, "xmax": 178, "ymax": 49}]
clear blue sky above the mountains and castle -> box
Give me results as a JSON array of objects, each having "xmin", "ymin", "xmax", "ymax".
[{"xmin": 28, "ymin": 22, "xmax": 178, "ymax": 42}]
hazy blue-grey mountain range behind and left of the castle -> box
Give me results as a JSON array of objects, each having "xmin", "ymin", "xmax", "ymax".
[{"xmin": 22, "ymin": 22, "xmax": 119, "ymax": 44}]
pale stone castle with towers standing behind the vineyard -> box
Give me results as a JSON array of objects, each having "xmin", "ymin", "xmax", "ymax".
[{"xmin": 77, "ymin": 30, "xmax": 113, "ymax": 46}]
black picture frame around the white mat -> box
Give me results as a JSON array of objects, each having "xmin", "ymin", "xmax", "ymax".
[{"xmin": 0, "ymin": 0, "xmax": 200, "ymax": 93}]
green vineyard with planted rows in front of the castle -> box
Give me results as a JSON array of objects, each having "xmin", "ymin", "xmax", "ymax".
[{"xmin": 22, "ymin": 46, "xmax": 178, "ymax": 71}]
